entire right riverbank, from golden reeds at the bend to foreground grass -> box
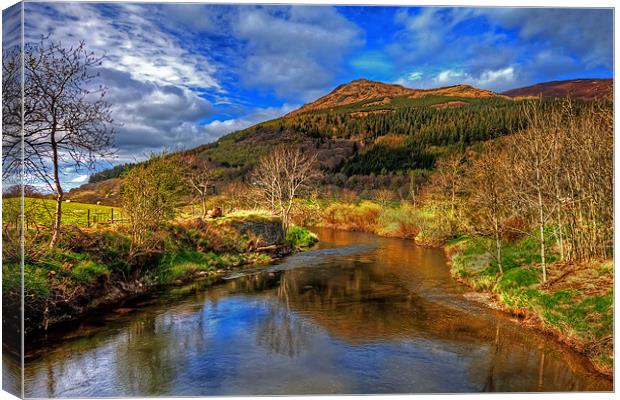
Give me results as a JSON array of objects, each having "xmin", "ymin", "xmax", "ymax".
[{"xmin": 308, "ymin": 201, "xmax": 613, "ymax": 376}]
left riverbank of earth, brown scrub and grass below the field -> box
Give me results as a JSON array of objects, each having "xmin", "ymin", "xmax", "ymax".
[{"xmin": 3, "ymin": 213, "xmax": 317, "ymax": 337}]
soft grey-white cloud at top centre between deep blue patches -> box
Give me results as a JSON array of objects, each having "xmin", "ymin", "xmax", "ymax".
[{"xmin": 233, "ymin": 6, "xmax": 363, "ymax": 101}]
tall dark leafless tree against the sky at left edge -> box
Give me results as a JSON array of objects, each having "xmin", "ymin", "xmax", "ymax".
[{"xmin": 3, "ymin": 38, "xmax": 114, "ymax": 247}]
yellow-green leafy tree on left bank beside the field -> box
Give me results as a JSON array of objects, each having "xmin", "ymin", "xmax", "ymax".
[{"xmin": 121, "ymin": 153, "xmax": 181, "ymax": 255}]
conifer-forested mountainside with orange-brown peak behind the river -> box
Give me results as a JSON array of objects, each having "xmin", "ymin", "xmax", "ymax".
[{"xmin": 68, "ymin": 79, "xmax": 605, "ymax": 204}]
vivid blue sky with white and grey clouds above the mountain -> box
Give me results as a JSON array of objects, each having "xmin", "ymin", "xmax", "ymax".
[{"xmin": 5, "ymin": 3, "xmax": 613, "ymax": 186}]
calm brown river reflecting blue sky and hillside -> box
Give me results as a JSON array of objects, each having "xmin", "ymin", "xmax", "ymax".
[{"xmin": 3, "ymin": 229, "xmax": 612, "ymax": 397}]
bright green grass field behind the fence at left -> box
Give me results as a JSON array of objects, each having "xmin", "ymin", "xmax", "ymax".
[{"xmin": 2, "ymin": 198, "xmax": 122, "ymax": 227}]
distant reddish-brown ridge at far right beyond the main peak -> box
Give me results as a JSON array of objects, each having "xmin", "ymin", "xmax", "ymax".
[{"xmin": 502, "ymin": 79, "xmax": 614, "ymax": 100}]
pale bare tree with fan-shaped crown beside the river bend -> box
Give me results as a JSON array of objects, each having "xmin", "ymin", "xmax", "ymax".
[{"xmin": 251, "ymin": 147, "xmax": 322, "ymax": 232}]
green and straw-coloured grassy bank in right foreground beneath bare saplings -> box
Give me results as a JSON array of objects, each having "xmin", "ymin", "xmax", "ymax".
[{"xmin": 446, "ymin": 235, "xmax": 613, "ymax": 375}]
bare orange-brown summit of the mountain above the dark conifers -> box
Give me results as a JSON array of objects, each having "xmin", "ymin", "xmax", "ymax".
[{"xmin": 289, "ymin": 79, "xmax": 500, "ymax": 115}]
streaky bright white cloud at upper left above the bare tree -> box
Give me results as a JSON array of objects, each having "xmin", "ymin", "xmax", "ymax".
[{"xmin": 25, "ymin": 3, "xmax": 221, "ymax": 89}]
